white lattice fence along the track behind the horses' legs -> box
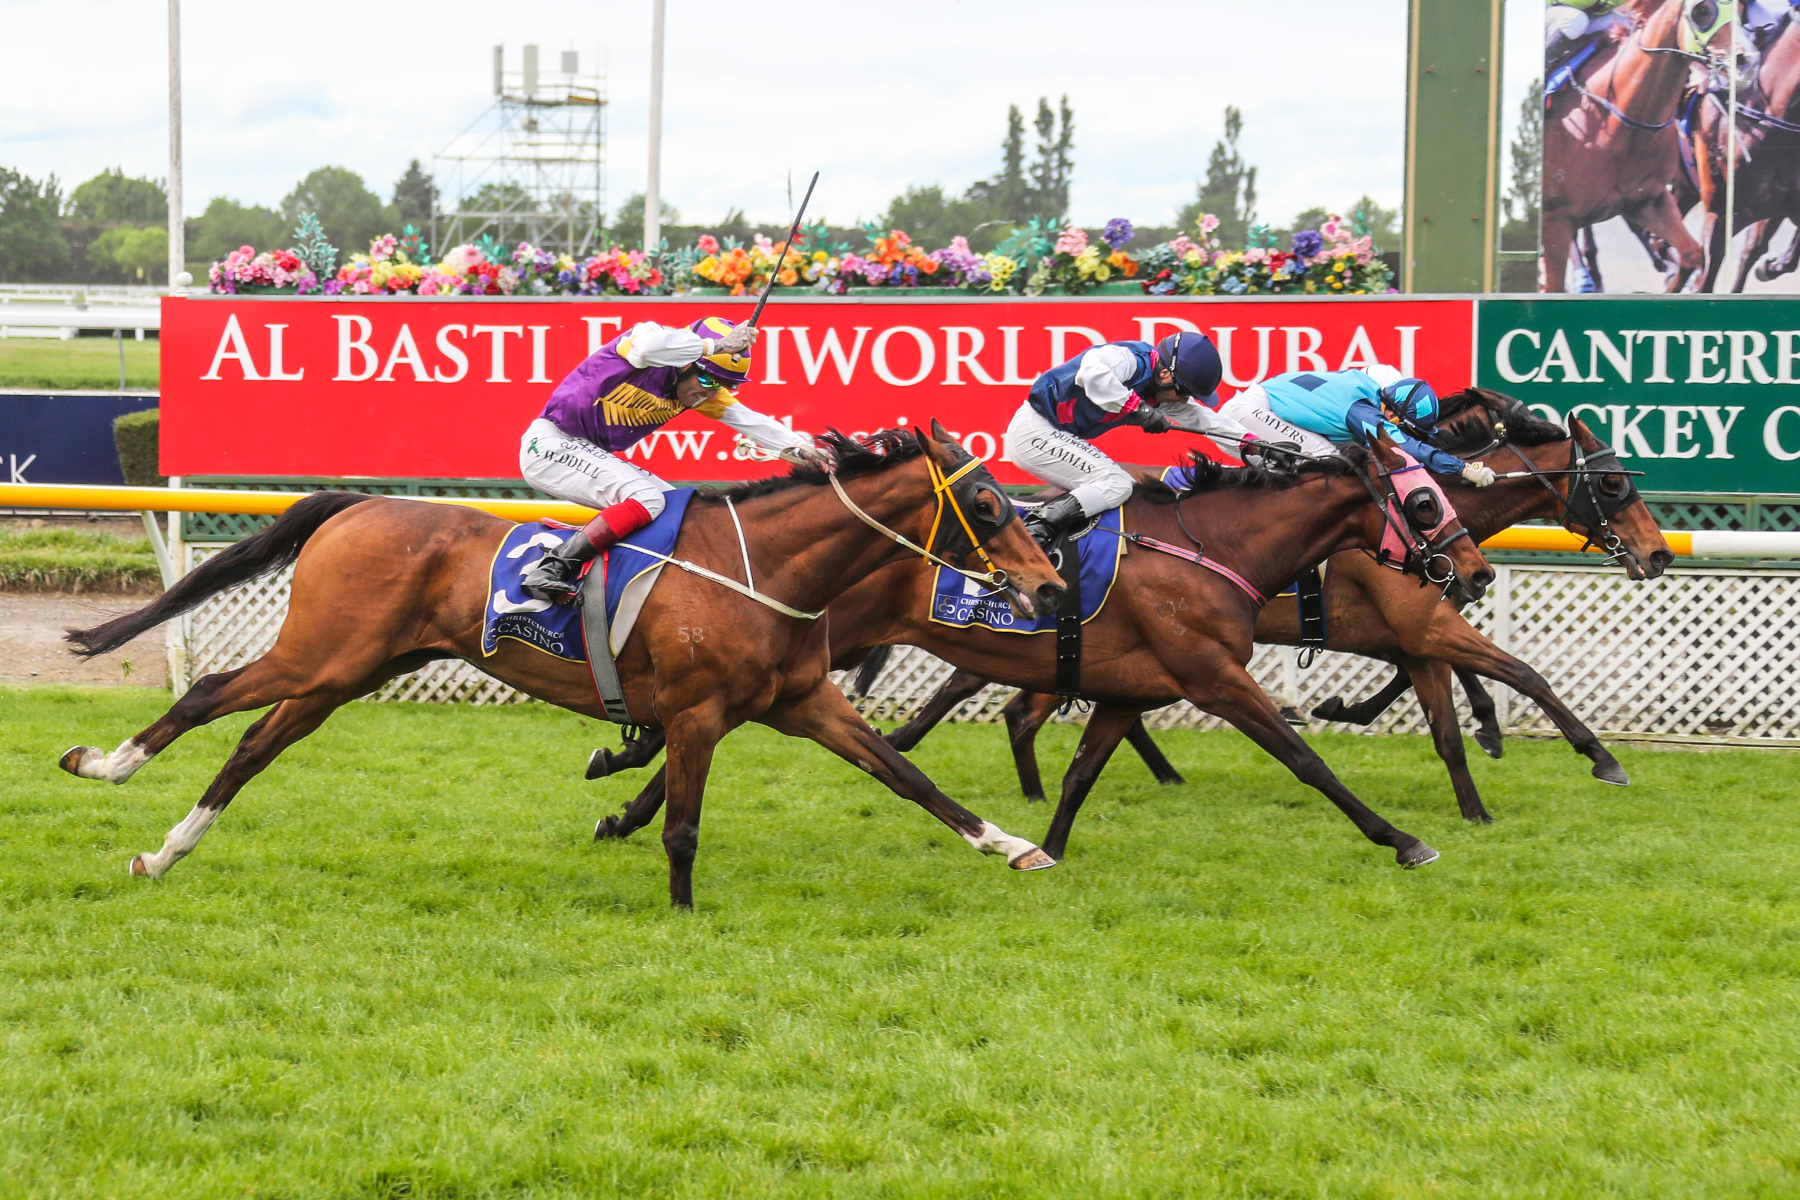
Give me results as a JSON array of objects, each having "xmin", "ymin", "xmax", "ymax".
[{"xmin": 171, "ymin": 545, "xmax": 1800, "ymax": 739}]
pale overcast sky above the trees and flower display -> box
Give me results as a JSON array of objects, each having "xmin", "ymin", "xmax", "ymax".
[{"xmin": 0, "ymin": 0, "xmax": 1543, "ymax": 225}]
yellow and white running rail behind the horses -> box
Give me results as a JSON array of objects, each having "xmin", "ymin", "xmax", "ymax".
[{"xmin": 0, "ymin": 484, "xmax": 1800, "ymax": 558}]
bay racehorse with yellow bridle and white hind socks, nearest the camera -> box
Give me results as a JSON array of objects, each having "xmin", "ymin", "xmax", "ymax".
[{"xmin": 61, "ymin": 423, "xmax": 1062, "ymax": 907}]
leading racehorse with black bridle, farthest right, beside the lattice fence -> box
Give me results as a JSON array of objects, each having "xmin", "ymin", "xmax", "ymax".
[{"xmin": 856, "ymin": 389, "xmax": 1674, "ymax": 831}]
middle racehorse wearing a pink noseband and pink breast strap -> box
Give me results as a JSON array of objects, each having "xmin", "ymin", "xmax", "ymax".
[{"xmin": 594, "ymin": 435, "xmax": 1494, "ymax": 867}]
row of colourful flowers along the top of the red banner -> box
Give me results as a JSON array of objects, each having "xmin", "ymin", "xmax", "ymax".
[{"xmin": 211, "ymin": 214, "xmax": 1393, "ymax": 297}]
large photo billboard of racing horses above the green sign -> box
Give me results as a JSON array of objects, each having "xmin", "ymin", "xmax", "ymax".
[{"xmin": 1539, "ymin": 0, "xmax": 1800, "ymax": 293}]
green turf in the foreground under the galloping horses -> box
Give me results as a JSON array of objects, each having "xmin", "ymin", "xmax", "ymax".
[{"xmin": 0, "ymin": 689, "xmax": 1800, "ymax": 1200}]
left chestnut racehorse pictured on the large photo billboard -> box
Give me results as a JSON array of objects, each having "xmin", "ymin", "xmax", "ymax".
[{"xmin": 1541, "ymin": 0, "xmax": 1730, "ymax": 291}]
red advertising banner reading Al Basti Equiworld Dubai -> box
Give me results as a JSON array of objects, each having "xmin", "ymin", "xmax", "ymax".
[{"xmin": 162, "ymin": 297, "xmax": 1474, "ymax": 482}]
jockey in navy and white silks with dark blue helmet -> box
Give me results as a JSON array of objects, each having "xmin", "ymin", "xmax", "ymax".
[{"xmin": 1006, "ymin": 333, "xmax": 1256, "ymax": 545}]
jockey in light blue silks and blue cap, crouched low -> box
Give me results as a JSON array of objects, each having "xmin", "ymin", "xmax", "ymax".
[{"xmin": 1219, "ymin": 365, "xmax": 1494, "ymax": 488}]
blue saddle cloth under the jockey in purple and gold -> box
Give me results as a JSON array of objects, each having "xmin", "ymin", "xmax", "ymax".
[{"xmin": 481, "ymin": 488, "xmax": 693, "ymax": 662}]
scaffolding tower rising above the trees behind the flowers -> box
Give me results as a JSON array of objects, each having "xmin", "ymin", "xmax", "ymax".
[{"xmin": 430, "ymin": 45, "xmax": 607, "ymax": 257}]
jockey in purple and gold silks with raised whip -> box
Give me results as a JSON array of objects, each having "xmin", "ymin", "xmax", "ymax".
[{"xmin": 518, "ymin": 317, "xmax": 826, "ymax": 599}]
